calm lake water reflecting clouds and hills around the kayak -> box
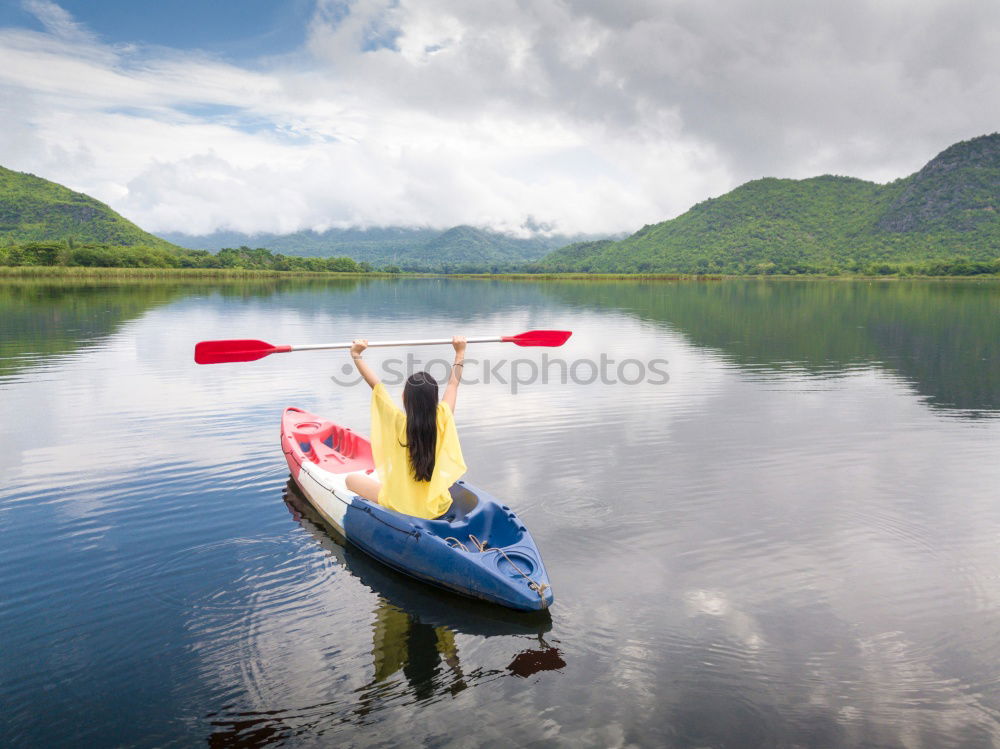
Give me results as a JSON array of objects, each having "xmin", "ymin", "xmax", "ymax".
[{"xmin": 0, "ymin": 280, "xmax": 1000, "ymax": 747}]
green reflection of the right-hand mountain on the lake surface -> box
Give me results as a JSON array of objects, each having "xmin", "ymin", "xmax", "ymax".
[{"xmin": 538, "ymin": 280, "xmax": 1000, "ymax": 417}]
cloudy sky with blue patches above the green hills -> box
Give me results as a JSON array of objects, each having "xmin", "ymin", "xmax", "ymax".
[{"xmin": 0, "ymin": 0, "xmax": 1000, "ymax": 234}]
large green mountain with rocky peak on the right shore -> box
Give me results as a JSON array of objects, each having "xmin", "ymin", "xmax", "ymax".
[{"xmin": 537, "ymin": 133, "xmax": 1000, "ymax": 273}]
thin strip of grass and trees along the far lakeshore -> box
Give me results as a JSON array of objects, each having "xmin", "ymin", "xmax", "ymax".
[{"xmin": 0, "ymin": 265, "xmax": 1000, "ymax": 282}]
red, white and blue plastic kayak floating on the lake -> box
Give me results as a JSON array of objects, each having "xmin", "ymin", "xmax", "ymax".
[{"xmin": 281, "ymin": 408, "xmax": 553, "ymax": 611}]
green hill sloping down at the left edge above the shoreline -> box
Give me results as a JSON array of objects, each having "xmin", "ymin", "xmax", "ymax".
[{"xmin": 0, "ymin": 167, "xmax": 177, "ymax": 249}]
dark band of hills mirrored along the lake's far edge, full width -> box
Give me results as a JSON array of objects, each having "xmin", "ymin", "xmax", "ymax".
[{"xmin": 0, "ymin": 278, "xmax": 1000, "ymax": 416}]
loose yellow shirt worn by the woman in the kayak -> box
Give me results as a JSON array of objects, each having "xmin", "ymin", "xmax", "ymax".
[{"xmin": 372, "ymin": 382, "xmax": 465, "ymax": 518}]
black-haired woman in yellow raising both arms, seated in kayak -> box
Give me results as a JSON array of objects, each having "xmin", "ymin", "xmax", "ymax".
[{"xmin": 347, "ymin": 336, "xmax": 465, "ymax": 518}]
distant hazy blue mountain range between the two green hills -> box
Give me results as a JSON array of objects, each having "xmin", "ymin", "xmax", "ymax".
[{"xmin": 161, "ymin": 226, "xmax": 592, "ymax": 270}]
